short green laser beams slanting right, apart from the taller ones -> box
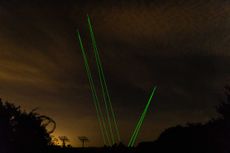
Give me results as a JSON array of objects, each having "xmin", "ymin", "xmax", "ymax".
[{"xmin": 128, "ymin": 87, "xmax": 156, "ymax": 147}]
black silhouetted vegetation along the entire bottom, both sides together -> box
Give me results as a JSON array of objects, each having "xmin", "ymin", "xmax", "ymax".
[{"xmin": 0, "ymin": 86, "xmax": 230, "ymax": 153}]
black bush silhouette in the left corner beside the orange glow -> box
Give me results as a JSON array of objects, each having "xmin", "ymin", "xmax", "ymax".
[{"xmin": 0, "ymin": 99, "xmax": 55, "ymax": 153}]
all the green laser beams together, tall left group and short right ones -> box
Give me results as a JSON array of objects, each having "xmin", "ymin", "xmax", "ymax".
[{"xmin": 77, "ymin": 15, "xmax": 156, "ymax": 147}]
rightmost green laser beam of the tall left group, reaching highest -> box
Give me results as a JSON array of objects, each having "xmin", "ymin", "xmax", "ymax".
[{"xmin": 88, "ymin": 16, "xmax": 120, "ymax": 141}]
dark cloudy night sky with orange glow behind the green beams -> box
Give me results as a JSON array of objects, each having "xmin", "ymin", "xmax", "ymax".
[{"xmin": 0, "ymin": 0, "xmax": 230, "ymax": 145}]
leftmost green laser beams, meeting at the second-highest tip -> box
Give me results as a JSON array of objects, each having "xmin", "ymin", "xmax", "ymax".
[{"xmin": 77, "ymin": 32, "xmax": 111, "ymax": 145}]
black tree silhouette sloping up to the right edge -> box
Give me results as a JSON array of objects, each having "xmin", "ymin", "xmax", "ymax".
[{"xmin": 137, "ymin": 86, "xmax": 230, "ymax": 153}]
